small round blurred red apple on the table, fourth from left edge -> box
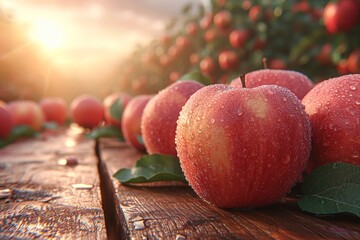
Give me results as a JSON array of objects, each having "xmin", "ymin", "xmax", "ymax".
[{"xmin": 70, "ymin": 94, "xmax": 104, "ymax": 128}]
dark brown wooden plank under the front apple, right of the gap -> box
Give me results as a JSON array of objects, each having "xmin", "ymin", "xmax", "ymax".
[{"xmin": 100, "ymin": 141, "xmax": 360, "ymax": 239}]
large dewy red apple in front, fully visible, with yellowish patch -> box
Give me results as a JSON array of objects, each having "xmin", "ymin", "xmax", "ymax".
[{"xmin": 176, "ymin": 84, "xmax": 311, "ymax": 208}]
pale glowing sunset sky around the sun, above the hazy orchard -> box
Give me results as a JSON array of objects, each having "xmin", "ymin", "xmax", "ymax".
[{"xmin": 0, "ymin": 0, "xmax": 207, "ymax": 81}]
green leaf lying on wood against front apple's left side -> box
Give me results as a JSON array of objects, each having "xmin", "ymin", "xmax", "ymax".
[{"xmin": 114, "ymin": 154, "xmax": 186, "ymax": 184}]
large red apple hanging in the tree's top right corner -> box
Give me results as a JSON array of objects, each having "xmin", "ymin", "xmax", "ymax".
[{"xmin": 323, "ymin": 0, "xmax": 360, "ymax": 34}]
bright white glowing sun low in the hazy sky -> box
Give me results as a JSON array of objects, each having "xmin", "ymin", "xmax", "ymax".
[{"xmin": 29, "ymin": 19, "xmax": 65, "ymax": 51}]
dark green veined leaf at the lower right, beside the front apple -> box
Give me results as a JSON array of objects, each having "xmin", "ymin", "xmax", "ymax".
[{"xmin": 298, "ymin": 163, "xmax": 360, "ymax": 217}]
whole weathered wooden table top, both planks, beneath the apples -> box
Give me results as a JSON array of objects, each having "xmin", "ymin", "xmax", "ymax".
[{"xmin": 0, "ymin": 126, "xmax": 360, "ymax": 240}]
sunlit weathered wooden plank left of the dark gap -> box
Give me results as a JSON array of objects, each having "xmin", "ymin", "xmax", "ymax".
[{"xmin": 0, "ymin": 128, "xmax": 106, "ymax": 239}]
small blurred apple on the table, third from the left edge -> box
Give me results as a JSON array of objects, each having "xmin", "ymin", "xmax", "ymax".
[{"xmin": 39, "ymin": 97, "xmax": 68, "ymax": 125}]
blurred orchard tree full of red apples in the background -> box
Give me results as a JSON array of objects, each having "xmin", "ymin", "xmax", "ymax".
[{"xmin": 116, "ymin": 0, "xmax": 360, "ymax": 94}]
